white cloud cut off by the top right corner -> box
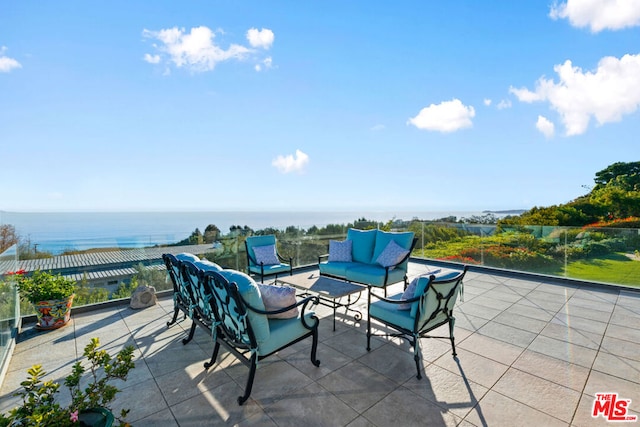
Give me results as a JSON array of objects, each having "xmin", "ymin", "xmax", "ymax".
[{"xmin": 549, "ymin": 0, "xmax": 640, "ymax": 33}]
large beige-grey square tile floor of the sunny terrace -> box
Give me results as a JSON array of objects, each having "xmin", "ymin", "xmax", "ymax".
[{"xmin": 0, "ymin": 263, "xmax": 640, "ymax": 427}]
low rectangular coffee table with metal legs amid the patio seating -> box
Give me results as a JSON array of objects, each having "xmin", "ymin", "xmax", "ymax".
[{"xmin": 276, "ymin": 271, "xmax": 367, "ymax": 331}]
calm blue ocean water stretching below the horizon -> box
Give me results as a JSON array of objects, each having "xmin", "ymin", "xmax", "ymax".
[{"xmin": 0, "ymin": 211, "xmax": 482, "ymax": 254}]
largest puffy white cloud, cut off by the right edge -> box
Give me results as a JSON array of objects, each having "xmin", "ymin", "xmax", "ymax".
[{"xmin": 509, "ymin": 54, "xmax": 640, "ymax": 135}]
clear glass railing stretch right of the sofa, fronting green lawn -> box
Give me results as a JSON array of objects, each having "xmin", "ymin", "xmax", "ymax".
[{"xmin": 413, "ymin": 222, "xmax": 640, "ymax": 286}]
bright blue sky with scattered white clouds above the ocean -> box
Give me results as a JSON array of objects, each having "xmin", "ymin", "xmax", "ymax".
[{"xmin": 0, "ymin": 0, "xmax": 640, "ymax": 212}]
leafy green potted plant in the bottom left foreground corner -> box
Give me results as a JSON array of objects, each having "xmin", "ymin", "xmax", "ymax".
[{"xmin": 0, "ymin": 338, "xmax": 135, "ymax": 427}]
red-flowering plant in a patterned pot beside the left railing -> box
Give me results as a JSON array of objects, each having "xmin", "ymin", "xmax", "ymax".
[{"xmin": 15, "ymin": 270, "xmax": 76, "ymax": 329}]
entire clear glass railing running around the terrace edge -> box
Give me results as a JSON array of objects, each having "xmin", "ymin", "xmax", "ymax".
[{"xmin": 5, "ymin": 214, "xmax": 640, "ymax": 314}]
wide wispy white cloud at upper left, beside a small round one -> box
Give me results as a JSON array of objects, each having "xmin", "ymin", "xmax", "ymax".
[{"xmin": 142, "ymin": 26, "xmax": 250, "ymax": 71}]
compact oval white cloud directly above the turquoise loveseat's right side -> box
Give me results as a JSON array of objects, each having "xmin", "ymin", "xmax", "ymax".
[{"xmin": 408, "ymin": 99, "xmax": 476, "ymax": 132}]
